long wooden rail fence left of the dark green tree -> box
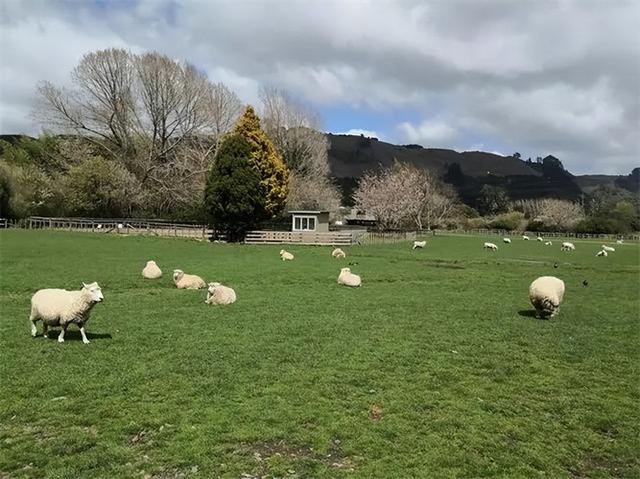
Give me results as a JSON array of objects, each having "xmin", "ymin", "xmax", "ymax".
[{"xmin": 18, "ymin": 216, "xmax": 212, "ymax": 239}]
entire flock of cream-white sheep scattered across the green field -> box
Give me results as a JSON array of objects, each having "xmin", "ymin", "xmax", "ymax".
[{"xmin": 29, "ymin": 235, "xmax": 622, "ymax": 344}]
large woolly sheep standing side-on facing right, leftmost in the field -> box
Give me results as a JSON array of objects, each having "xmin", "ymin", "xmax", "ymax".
[{"xmin": 29, "ymin": 283, "xmax": 104, "ymax": 344}]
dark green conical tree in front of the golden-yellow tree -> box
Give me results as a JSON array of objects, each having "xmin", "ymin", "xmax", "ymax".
[{"xmin": 204, "ymin": 134, "xmax": 269, "ymax": 241}]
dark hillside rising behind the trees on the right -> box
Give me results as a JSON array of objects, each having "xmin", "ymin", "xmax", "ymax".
[{"xmin": 327, "ymin": 134, "xmax": 637, "ymax": 206}]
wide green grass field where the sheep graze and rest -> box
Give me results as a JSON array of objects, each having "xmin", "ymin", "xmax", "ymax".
[{"xmin": 0, "ymin": 230, "xmax": 640, "ymax": 479}]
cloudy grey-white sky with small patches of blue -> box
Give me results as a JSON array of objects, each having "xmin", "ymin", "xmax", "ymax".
[{"xmin": 0, "ymin": 0, "xmax": 640, "ymax": 174}]
